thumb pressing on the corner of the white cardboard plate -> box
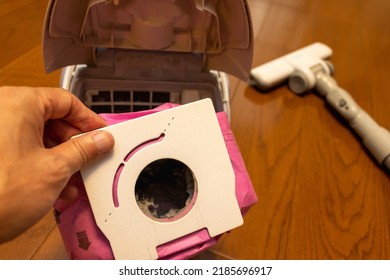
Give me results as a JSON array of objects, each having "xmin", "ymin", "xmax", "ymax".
[{"xmin": 53, "ymin": 130, "xmax": 115, "ymax": 174}]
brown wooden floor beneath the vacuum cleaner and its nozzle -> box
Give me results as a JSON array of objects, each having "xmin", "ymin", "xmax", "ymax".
[{"xmin": 0, "ymin": 0, "xmax": 390, "ymax": 259}]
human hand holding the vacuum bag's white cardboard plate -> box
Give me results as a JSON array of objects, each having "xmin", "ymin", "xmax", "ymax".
[{"xmin": 0, "ymin": 87, "xmax": 114, "ymax": 243}]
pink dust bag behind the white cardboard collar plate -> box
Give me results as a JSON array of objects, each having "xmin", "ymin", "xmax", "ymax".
[{"xmin": 54, "ymin": 103, "xmax": 257, "ymax": 260}]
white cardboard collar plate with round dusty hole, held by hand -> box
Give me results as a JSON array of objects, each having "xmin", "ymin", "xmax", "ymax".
[{"xmin": 81, "ymin": 99, "xmax": 243, "ymax": 259}]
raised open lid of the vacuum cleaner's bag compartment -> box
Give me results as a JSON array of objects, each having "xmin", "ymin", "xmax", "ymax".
[{"xmin": 43, "ymin": 0, "xmax": 253, "ymax": 79}]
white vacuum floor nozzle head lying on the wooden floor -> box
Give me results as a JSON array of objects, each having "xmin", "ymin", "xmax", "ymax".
[{"xmin": 251, "ymin": 43, "xmax": 332, "ymax": 90}]
